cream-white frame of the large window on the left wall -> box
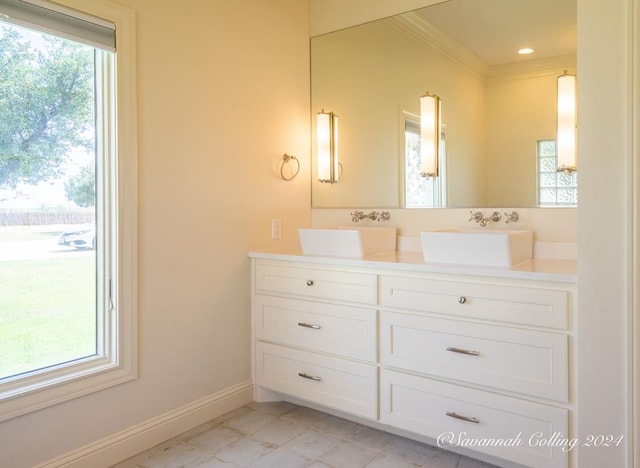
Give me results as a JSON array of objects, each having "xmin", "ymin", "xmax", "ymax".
[{"xmin": 0, "ymin": 0, "xmax": 138, "ymax": 421}]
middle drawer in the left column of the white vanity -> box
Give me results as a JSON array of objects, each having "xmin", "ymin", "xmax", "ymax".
[{"xmin": 255, "ymin": 295, "xmax": 378, "ymax": 362}]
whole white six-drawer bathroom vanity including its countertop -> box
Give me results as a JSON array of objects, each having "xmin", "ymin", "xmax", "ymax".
[{"xmin": 250, "ymin": 252, "xmax": 576, "ymax": 467}]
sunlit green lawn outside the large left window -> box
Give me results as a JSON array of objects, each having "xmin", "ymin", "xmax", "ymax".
[{"xmin": 0, "ymin": 226, "xmax": 96, "ymax": 378}]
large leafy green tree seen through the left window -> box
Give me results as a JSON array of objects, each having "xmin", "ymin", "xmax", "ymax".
[{"xmin": 0, "ymin": 26, "xmax": 94, "ymax": 188}]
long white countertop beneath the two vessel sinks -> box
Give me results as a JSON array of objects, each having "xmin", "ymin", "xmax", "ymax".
[{"xmin": 249, "ymin": 251, "xmax": 578, "ymax": 283}]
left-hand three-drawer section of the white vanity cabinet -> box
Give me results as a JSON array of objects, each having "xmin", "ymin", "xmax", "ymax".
[{"xmin": 253, "ymin": 261, "xmax": 378, "ymax": 419}]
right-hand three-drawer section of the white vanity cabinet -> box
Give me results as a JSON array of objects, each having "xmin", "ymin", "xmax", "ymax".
[{"xmin": 379, "ymin": 274, "xmax": 572, "ymax": 468}]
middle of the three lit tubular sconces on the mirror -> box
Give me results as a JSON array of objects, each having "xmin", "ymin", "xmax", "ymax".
[{"xmin": 420, "ymin": 93, "xmax": 441, "ymax": 177}]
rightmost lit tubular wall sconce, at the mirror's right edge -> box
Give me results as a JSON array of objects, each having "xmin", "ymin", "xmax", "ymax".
[{"xmin": 556, "ymin": 70, "xmax": 577, "ymax": 173}]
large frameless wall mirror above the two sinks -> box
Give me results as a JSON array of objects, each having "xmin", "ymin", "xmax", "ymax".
[{"xmin": 311, "ymin": 0, "xmax": 577, "ymax": 208}]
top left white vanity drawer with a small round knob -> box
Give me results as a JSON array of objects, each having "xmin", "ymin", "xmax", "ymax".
[{"xmin": 255, "ymin": 263, "xmax": 378, "ymax": 304}]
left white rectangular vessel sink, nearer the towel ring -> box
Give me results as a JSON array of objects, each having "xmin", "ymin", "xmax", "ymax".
[{"xmin": 298, "ymin": 227, "xmax": 396, "ymax": 258}]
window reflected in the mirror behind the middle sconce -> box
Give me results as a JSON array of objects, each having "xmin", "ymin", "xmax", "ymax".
[{"xmin": 403, "ymin": 112, "xmax": 446, "ymax": 208}]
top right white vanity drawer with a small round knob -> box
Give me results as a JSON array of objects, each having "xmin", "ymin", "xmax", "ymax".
[{"xmin": 380, "ymin": 276, "xmax": 569, "ymax": 330}]
